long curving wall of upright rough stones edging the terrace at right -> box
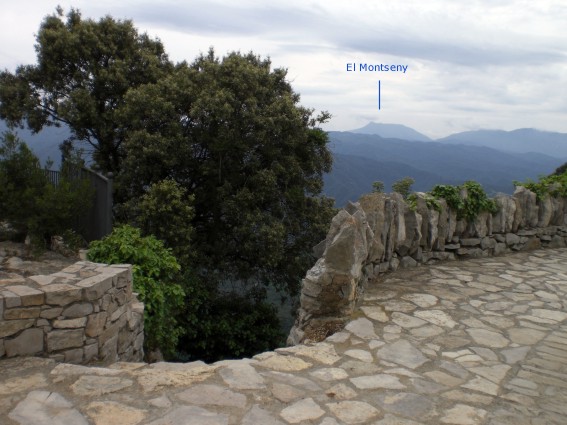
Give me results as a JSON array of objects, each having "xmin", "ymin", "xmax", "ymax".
[{"xmin": 288, "ymin": 187, "xmax": 567, "ymax": 345}]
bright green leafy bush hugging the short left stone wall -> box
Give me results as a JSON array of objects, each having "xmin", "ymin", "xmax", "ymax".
[{"xmin": 88, "ymin": 225, "xmax": 185, "ymax": 356}]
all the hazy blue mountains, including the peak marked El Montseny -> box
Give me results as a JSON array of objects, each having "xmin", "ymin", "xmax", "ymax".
[{"xmin": 0, "ymin": 121, "xmax": 567, "ymax": 207}]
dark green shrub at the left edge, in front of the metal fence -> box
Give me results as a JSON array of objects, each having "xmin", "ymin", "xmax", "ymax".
[{"xmin": 0, "ymin": 133, "xmax": 94, "ymax": 249}]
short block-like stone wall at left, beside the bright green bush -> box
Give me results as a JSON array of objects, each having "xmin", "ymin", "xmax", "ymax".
[{"xmin": 0, "ymin": 261, "xmax": 144, "ymax": 364}]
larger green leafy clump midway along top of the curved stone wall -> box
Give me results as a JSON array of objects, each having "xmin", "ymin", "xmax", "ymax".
[{"xmin": 430, "ymin": 181, "xmax": 498, "ymax": 221}]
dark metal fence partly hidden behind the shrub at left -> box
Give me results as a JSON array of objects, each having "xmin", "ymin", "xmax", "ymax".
[{"xmin": 45, "ymin": 167, "xmax": 113, "ymax": 242}]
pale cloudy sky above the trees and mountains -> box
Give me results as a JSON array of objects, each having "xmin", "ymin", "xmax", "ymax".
[{"xmin": 0, "ymin": 0, "xmax": 567, "ymax": 138}]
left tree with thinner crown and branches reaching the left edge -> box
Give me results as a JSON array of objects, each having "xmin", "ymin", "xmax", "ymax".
[{"xmin": 0, "ymin": 8, "xmax": 172, "ymax": 172}]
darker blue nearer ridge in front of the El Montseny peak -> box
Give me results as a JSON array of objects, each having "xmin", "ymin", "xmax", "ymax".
[{"xmin": 324, "ymin": 132, "xmax": 567, "ymax": 206}]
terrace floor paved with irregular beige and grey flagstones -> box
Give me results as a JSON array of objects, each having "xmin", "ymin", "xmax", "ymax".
[{"xmin": 0, "ymin": 249, "xmax": 567, "ymax": 425}]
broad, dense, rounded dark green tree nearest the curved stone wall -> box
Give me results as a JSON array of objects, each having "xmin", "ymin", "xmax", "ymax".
[{"xmin": 119, "ymin": 50, "xmax": 333, "ymax": 293}]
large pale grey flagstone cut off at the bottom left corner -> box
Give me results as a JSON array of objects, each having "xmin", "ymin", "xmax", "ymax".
[{"xmin": 8, "ymin": 391, "xmax": 88, "ymax": 425}]
